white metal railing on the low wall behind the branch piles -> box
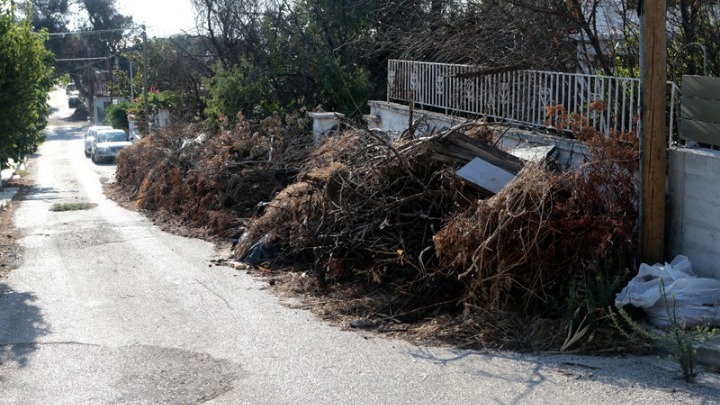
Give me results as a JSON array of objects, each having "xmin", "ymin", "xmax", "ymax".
[{"xmin": 387, "ymin": 59, "xmax": 677, "ymax": 140}]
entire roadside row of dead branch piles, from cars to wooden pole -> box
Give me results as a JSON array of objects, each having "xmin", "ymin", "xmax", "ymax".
[{"xmin": 117, "ymin": 112, "xmax": 637, "ymax": 349}]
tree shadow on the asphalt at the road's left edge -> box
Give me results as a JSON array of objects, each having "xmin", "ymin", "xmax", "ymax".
[{"xmin": 0, "ymin": 283, "xmax": 50, "ymax": 367}]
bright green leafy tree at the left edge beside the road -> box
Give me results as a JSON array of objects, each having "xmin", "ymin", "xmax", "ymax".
[{"xmin": 0, "ymin": 0, "xmax": 54, "ymax": 168}]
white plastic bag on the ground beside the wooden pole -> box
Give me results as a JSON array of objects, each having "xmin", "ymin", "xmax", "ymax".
[{"xmin": 615, "ymin": 256, "xmax": 720, "ymax": 327}]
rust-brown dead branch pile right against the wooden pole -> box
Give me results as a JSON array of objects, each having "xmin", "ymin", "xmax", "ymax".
[{"xmin": 433, "ymin": 131, "xmax": 637, "ymax": 317}]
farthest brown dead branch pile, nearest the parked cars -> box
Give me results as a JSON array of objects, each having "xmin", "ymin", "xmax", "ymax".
[{"xmin": 116, "ymin": 111, "xmax": 308, "ymax": 236}]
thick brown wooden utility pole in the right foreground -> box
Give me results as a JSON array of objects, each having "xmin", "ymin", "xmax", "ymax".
[{"xmin": 640, "ymin": 0, "xmax": 668, "ymax": 264}]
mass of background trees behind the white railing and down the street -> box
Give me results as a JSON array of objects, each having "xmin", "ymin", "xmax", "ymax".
[{"xmin": 19, "ymin": 0, "xmax": 720, "ymax": 136}]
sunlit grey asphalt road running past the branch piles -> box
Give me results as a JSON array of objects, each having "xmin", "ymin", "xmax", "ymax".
[{"xmin": 0, "ymin": 89, "xmax": 720, "ymax": 404}]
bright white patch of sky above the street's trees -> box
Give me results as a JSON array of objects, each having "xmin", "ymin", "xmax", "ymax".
[{"xmin": 115, "ymin": 0, "xmax": 195, "ymax": 38}]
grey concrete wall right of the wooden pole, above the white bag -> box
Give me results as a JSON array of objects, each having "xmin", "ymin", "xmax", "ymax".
[{"xmin": 666, "ymin": 148, "xmax": 720, "ymax": 278}]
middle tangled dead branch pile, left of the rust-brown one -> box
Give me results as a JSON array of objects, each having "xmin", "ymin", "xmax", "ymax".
[{"xmin": 236, "ymin": 126, "xmax": 496, "ymax": 311}]
